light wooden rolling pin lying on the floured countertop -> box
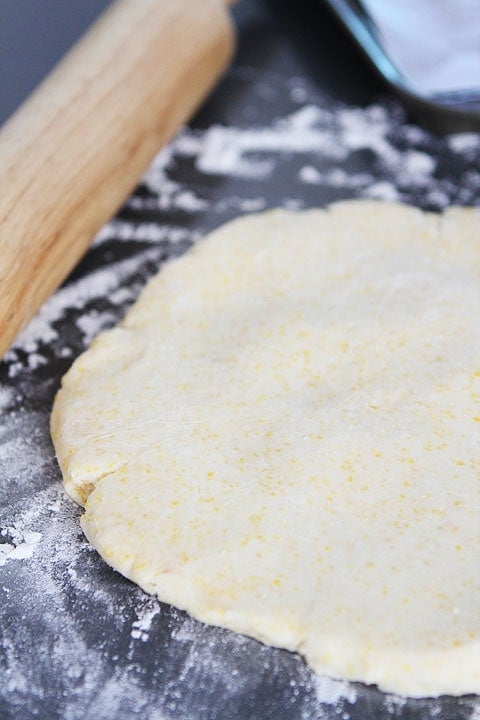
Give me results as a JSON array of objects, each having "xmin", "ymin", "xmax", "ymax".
[{"xmin": 0, "ymin": 0, "xmax": 234, "ymax": 356}]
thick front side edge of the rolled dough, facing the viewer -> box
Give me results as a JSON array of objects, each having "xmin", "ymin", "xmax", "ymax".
[{"xmin": 80, "ymin": 481, "xmax": 480, "ymax": 698}]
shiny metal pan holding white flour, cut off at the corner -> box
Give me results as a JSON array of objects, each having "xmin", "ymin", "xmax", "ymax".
[{"xmin": 323, "ymin": 0, "xmax": 480, "ymax": 133}]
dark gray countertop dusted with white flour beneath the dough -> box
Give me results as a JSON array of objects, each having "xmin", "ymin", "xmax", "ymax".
[{"xmin": 0, "ymin": 0, "xmax": 480, "ymax": 720}]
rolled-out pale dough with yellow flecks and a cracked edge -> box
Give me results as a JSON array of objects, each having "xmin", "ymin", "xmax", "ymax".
[{"xmin": 52, "ymin": 202, "xmax": 480, "ymax": 696}]
